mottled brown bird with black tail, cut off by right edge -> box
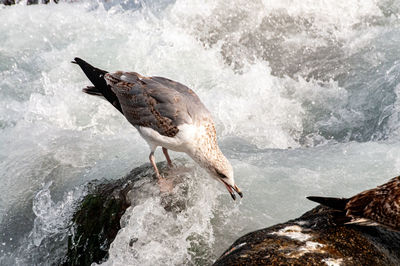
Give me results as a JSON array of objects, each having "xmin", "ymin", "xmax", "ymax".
[{"xmin": 307, "ymin": 176, "xmax": 400, "ymax": 231}]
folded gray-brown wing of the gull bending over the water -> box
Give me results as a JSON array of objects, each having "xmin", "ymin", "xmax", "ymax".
[{"xmin": 105, "ymin": 72, "xmax": 209, "ymax": 137}]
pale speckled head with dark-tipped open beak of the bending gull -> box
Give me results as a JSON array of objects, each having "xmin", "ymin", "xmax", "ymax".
[{"xmin": 211, "ymin": 157, "xmax": 243, "ymax": 200}]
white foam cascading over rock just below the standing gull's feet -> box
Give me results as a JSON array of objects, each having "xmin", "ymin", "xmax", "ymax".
[{"xmin": 103, "ymin": 163, "xmax": 223, "ymax": 265}]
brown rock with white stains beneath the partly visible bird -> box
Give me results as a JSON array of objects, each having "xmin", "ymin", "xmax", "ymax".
[{"xmin": 215, "ymin": 206, "xmax": 400, "ymax": 265}]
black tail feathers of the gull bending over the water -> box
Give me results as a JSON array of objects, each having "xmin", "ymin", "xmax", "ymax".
[{"xmin": 72, "ymin": 57, "xmax": 122, "ymax": 113}]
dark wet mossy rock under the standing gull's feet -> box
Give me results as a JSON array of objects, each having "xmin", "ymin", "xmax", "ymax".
[{"xmin": 61, "ymin": 163, "xmax": 165, "ymax": 265}]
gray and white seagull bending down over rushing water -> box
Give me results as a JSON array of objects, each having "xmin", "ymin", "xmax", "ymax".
[{"xmin": 72, "ymin": 58, "xmax": 243, "ymax": 200}]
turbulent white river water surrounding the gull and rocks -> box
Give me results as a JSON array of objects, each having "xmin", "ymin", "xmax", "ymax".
[{"xmin": 0, "ymin": 0, "xmax": 400, "ymax": 265}]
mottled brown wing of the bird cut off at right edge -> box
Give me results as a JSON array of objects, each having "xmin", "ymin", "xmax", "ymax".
[{"xmin": 346, "ymin": 177, "xmax": 400, "ymax": 230}]
